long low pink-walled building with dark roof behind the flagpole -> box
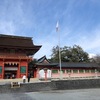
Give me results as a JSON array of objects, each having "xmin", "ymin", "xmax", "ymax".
[{"xmin": 33, "ymin": 56, "xmax": 100, "ymax": 79}]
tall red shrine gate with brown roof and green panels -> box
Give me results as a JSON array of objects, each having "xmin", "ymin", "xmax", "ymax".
[{"xmin": 0, "ymin": 34, "xmax": 41, "ymax": 79}]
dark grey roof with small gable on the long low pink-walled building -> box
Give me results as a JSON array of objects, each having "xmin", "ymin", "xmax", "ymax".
[{"xmin": 36, "ymin": 56, "xmax": 100, "ymax": 68}]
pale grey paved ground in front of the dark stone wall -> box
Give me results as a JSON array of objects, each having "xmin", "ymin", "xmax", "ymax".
[{"xmin": 0, "ymin": 89, "xmax": 100, "ymax": 100}]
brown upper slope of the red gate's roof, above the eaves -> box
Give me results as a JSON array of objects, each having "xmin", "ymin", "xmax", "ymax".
[{"xmin": 0, "ymin": 35, "xmax": 34, "ymax": 47}]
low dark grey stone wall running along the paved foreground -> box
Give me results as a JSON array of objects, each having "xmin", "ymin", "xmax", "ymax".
[{"xmin": 0, "ymin": 79, "xmax": 100, "ymax": 93}]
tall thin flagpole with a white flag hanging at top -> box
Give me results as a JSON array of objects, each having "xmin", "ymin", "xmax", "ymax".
[{"xmin": 56, "ymin": 22, "xmax": 62, "ymax": 79}]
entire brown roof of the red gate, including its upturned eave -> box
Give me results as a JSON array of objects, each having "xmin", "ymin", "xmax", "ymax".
[{"xmin": 0, "ymin": 34, "xmax": 41, "ymax": 55}]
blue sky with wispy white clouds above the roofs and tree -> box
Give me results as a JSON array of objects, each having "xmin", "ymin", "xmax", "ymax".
[{"xmin": 0, "ymin": 0, "xmax": 100, "ymax": 58}]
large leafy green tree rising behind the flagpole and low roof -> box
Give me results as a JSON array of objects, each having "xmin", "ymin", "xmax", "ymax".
[{"xmin": 51, "ymin": 45, "xmax": 89, "ymax": 62}]
